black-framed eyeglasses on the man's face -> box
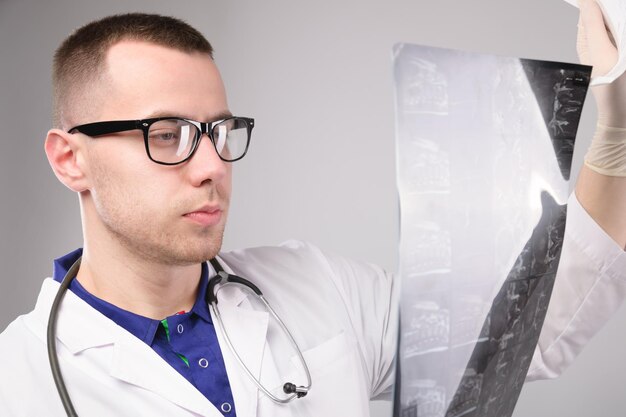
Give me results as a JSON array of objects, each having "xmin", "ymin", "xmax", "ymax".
[{"xmin": 68, "ymin": 117, "xmax": 254, "ymax": 165}]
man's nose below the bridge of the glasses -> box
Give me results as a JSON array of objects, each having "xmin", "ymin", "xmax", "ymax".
[{"xmin": 187, "ymin": 133, "xmax": 230, "ymax": 186}]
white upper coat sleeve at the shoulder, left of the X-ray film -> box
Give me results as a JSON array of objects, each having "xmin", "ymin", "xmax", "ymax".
[{"xmin": 312, "ymin": 247, "xmax": 399, "ymax": 399}]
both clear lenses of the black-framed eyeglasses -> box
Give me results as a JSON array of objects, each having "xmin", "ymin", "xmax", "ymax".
[{"xmin": 148, "ymin": 118, "xmax": 249, "ymax": 163}]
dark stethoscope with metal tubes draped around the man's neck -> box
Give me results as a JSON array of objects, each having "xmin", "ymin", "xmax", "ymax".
[{"xmin": 47, "ymin": 258, "xmax": 311, "ymax": 417}]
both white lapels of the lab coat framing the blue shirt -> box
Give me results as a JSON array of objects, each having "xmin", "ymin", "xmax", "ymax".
[{"xmin": 34, "ymin": 254, "xmax": 268, "ymax": 417}]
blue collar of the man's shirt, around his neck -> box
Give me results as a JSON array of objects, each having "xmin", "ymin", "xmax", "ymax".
[{"xmin": 52, "ymin": 248, "xmax": 215, "ymax": 345}]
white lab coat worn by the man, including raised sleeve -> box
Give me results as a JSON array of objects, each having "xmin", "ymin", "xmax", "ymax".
[{"xmin": 0, "ymin": 193, "xmax": 626, "ymax": 417}]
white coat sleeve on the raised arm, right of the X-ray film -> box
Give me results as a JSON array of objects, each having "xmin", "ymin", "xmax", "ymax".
[{"xmin": 526, "ymin": 194, "xmax": 626, "ymax": 381}]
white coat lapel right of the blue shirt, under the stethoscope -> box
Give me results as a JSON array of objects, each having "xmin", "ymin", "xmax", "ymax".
[{"xmin": 211, "ymin": 278, "xmax": 269, "ymax": 417}]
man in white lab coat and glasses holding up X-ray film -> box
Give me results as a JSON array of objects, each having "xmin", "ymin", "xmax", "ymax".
[{"xmin": 0, "ymin": 4, "xmax": 626, "ymax": 417}]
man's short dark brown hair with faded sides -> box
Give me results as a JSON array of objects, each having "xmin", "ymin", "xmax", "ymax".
[{"xmin": 52, "ymin": 13, "xmax": 213, "ymax": 127}]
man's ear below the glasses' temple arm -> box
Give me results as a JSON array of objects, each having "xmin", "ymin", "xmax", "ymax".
[{"xmin": 44, "ymin": 129, "xmax": 89, "ymax": 192}]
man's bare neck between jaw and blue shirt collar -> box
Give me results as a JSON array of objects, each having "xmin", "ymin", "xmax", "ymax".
[{"xmin": 76, "ymin": 237, "xmax": 201, "ymax": 320}]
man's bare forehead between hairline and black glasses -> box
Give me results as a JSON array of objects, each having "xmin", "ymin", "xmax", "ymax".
[{"xmin": 100, "ymin": 41, "xmax": 228, "ymax": 121}]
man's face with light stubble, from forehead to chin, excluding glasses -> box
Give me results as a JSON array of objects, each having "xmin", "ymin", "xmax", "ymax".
[{"xmin": 78, "ymin": 41, "xmax": 231, "ymax": 265}]
